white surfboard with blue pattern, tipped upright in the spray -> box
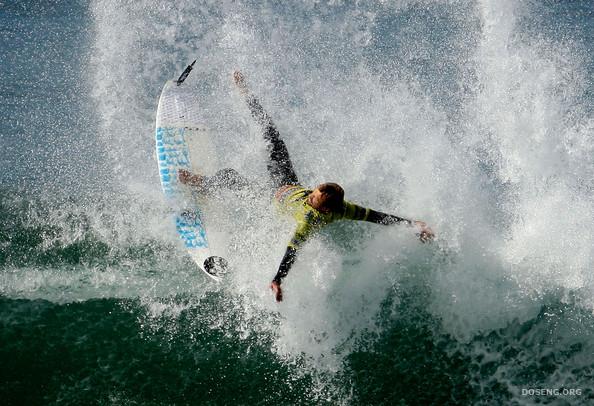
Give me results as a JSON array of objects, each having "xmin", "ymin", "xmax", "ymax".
[{"xmin": 155, "ymin": 61, "xmax": 227, "ymax": 281}]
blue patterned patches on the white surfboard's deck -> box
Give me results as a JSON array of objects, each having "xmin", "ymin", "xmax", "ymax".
[{"xmin": 156, "ymin": 127, "xmax": 208, "ymax": 248}]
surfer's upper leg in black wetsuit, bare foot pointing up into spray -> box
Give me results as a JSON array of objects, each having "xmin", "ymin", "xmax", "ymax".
[{"xmin": 233, "ymin": 71, "xmax": 299, "ymax": 189}]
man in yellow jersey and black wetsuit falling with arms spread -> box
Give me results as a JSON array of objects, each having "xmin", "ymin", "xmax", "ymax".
[{"xmin": 179, "ymin": 71, "xmax": 434, "ymax": 302}]
